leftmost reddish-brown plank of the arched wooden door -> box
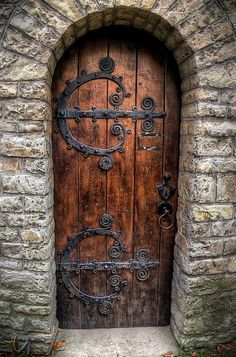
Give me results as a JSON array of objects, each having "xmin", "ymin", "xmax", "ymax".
[{"xmin": 52, "ymin": 47, "xmax": 80, "ymax": 328}]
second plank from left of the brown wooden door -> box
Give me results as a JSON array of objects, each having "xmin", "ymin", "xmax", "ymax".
[{"xmin": 78, "ymin": 35, "xmax": 107, "ymax": 328}]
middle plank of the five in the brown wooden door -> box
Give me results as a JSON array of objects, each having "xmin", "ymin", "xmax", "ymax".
[{"xmin": 107, "ymin": 31, "xmax": 136, "ymax": 327}]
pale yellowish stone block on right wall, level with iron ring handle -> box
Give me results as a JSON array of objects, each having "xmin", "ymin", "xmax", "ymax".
[{"xmin": 191, "ymin": 204, "xmax": 233, "ymax": 222}]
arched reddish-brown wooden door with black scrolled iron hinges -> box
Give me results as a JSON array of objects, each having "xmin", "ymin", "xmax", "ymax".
[{"xmin": 53, "ymin": 28, "xmax": 180, "ymax": 328}]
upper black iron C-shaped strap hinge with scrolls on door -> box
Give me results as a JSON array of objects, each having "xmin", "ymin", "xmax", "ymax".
[{"xmin": 54, "ymin": 57, "xmax": 166, "ymax": 170}]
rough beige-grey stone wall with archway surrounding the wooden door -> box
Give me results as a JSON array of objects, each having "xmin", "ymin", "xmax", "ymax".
[{"xmin": 0, "ymin": 0, "xmax": 236, "ymax": 355}]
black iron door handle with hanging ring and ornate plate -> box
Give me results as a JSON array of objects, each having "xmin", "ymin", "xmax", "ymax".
[{"xmin": 156, "ymin": 172, "xmax": 176, "ymax": 230}]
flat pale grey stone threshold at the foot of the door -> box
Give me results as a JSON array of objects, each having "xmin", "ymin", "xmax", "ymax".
[{"xmin": 54, "ymin": 326, "xmax": 178, "ymax": 357}]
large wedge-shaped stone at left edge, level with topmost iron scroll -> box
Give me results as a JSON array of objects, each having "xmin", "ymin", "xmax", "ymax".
[{"xmin": 0, "ymin": 50, "xmax": 49, "ymax": 81}]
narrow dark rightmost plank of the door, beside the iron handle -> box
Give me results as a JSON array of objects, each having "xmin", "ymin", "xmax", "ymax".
[{"xmin": 158, "ymin": 52, "xmax": 181, "ymax": 326}]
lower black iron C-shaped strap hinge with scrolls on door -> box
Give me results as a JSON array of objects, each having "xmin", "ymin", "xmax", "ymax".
[{"xmin": 57, "ymin": 214, "xmax": 160, "ymax": 315}]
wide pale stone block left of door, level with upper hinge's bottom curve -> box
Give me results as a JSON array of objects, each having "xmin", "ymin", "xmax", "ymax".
[{"xmin": 0, "ymin": 134, "xmax": 49, "ymax": 158}]
